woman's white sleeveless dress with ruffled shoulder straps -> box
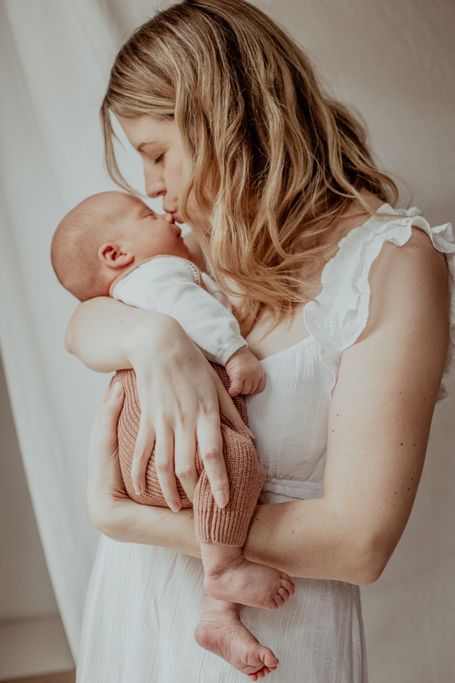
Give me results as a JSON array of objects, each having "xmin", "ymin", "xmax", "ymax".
[{"xmin": 77, "ymin": 204, "xmax": 455, "ymax": 683}]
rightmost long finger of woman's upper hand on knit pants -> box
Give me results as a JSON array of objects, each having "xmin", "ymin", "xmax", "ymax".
[{"xmin": 197, "ymin": 412, "xmax": 229, "ymax": 508}]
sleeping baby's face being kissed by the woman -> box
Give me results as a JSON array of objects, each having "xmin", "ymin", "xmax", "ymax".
[{"xmin": 116, "ymin": 196, "xmax": 190, "ymax": 262}]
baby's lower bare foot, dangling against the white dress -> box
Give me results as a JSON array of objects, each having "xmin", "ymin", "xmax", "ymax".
[{"xmin": 194, "ymin": 596, "xmax": 279, "ymax": 681}]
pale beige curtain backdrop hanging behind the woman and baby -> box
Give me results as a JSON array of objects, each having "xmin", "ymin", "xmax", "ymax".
[{"xmin": 0, "ymin": 0, "xmax": 455, "ymax": 683}]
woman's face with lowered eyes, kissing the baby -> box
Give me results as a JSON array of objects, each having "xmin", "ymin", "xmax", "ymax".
[{"xmin": 117, "ymin": 114, "xmax": 209, "ymax": 231}]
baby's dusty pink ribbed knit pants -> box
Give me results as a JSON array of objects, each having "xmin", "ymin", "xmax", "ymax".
[{"xmin": 114, "ymin": 363, "xmax": 266, "ymax": 546}]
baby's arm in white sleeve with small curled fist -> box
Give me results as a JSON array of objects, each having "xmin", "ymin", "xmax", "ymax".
[{"xmin": 112, "ymin": 255, "xmax": 265, "ymax": 396}]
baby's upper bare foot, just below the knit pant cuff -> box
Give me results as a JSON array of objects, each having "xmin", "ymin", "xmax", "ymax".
[{"xmin": 204, "ymin": 555, "xmax": 295, "ymax": 609}]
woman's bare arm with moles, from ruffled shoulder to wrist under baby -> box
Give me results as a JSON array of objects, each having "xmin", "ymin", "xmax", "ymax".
[{"xmin": 94, "ymin": 229, "xmax": 449, "ymax": 584}]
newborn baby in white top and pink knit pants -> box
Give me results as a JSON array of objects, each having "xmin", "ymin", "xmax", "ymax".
[{"xmin": 51, "ymin": 192, "xmax": 295, "ymax": 671}]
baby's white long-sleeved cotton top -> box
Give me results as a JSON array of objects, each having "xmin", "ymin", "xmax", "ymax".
[{"xmin": 111, "ymin": 254, "xmax": 246, "ymax": 365}]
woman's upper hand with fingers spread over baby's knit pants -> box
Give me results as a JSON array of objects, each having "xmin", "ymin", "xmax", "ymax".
[{"xmin": 126, "ymin": 318, "xmax": 253, "ymax": 511}]
